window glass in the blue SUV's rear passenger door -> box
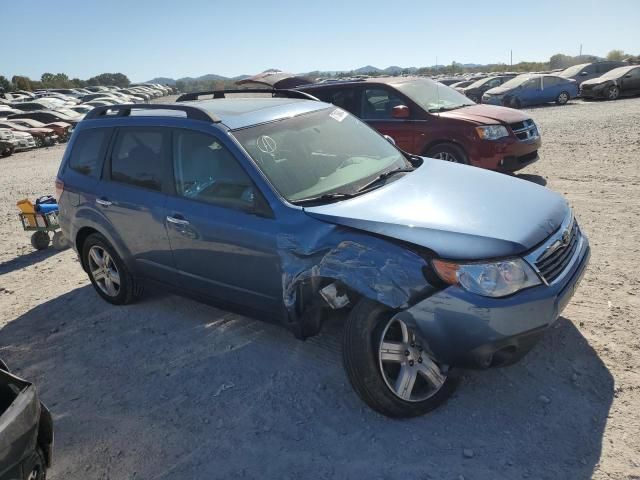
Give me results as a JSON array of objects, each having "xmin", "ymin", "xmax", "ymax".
[{"xmin": 111, "ymin": 128, "xmax": 171, "ymax": 191}]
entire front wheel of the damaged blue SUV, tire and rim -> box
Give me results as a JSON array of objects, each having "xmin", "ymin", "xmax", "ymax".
[{"xmin": 343, "ymin": 299, "xmax": 457, "ymax": 417}]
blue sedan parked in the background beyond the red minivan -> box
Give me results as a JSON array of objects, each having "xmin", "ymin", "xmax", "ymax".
[{"xmin": 482, "ymin": 74, "xmax": 578, "ymax": 108}]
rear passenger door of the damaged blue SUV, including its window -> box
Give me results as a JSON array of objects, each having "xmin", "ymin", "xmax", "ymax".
[{"xmin": 96, "ymin": 127, "xmax": 174, "ymax": 281}]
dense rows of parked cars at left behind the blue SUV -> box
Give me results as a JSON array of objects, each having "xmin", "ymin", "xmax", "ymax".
[{"xmin": 0, "ymin": 84, "xmax": 173, "ymax": 156}]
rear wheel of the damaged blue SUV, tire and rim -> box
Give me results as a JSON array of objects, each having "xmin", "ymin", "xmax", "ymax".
[{"xmin": 82, "ymin": 233, "xmax": 142, "ymax": 305}]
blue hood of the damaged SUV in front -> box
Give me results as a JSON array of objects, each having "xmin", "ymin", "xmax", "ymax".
[{"xmin": 304, "ymin": 159, "xmax": 569, "ymax": 260}]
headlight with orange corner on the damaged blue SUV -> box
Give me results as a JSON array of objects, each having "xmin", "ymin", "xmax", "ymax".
[{"xmin": 432, "ymin": 258, "xmax": 541, "ymax": 297}]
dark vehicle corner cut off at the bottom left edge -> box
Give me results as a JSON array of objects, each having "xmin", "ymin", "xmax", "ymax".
[{"xmin": 0, "ymin": 360, "xmax": 53, "ymax": 480}]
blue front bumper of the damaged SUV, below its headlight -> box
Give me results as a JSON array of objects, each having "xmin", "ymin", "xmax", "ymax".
[{"xmin": 396, "ymin": 231, "xmax": 590, "ymax": 368}]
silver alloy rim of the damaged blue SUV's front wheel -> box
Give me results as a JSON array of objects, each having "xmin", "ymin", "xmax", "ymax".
[{"xmin": 378, "ymin": 318, "xmax": 447, "ymax": 402}]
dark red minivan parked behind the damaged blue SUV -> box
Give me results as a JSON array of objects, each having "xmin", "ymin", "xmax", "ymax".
[{"xmin": 297, "ymin": 77, "xmax": 541, "ymax": 172}]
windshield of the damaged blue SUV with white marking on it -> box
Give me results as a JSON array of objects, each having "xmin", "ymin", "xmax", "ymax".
[{"xmin": 232, "ymin": 107, "xmax": 408, "ymax": 202}]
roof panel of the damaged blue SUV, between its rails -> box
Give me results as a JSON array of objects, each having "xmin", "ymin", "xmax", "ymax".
[{"xmin": 180, "ymin": 97, "xmax": 329, "ymax": 130}]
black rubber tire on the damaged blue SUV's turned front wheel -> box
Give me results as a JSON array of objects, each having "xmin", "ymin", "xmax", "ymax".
[{"xmin": 343, "ymin": 299, "xmax": 458, "ymax": 418}]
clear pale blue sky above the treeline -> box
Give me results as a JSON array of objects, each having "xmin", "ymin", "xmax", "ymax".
[{"xmin": 0, "ymin": 0, "xmax": 640, "ymax": 81}]
